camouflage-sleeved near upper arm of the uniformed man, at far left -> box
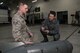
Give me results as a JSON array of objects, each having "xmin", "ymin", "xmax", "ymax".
[{"xmin": 12, "ymin": 19, "xmax": 21, "ymax": 41}]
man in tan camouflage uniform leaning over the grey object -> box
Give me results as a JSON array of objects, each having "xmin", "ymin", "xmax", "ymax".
[{"xmin": 12, "ymin": 3, "xmax": 33, "ymax": 44}]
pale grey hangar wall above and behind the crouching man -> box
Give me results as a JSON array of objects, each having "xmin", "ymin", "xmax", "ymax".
[{"xmin": 30, "ymin": 0, "xmax": 80, "ymax": 24}]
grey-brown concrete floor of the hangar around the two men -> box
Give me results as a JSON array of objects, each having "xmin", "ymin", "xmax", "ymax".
[{"xmin": 0, "ymin": 24, "xmax": 80, "ymax": 53}]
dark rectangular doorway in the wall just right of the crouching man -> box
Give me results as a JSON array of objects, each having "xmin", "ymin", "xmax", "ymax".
[{"xmin": 57, "ymin": 11, "xmax": 68, "ymax": 24}]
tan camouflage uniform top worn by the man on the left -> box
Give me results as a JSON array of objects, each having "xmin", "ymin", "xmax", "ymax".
[{"xmin": 12, "ymin": 12, "xmax": 31, "ymax": 41}]
